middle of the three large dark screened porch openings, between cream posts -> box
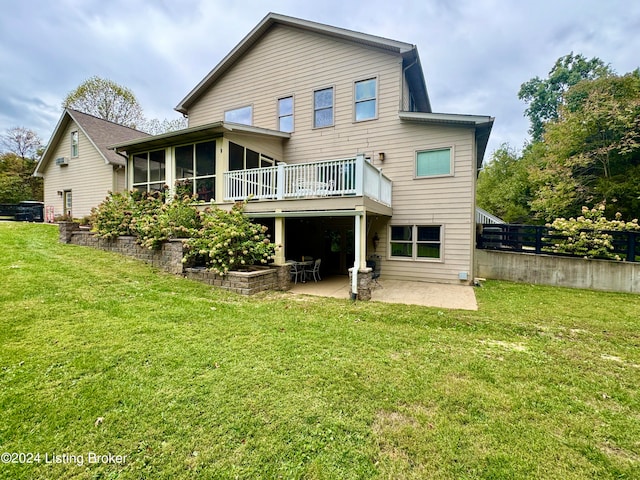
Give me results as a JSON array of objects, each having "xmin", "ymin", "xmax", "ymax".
[{"xmin": 175, "ymin": 141, "xmax": 216, "ymax": 202}]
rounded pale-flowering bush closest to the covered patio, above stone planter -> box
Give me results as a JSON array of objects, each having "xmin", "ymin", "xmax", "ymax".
[{"xmin": 183, "ymin": 203, "xmax": 276, "ymax": 276}]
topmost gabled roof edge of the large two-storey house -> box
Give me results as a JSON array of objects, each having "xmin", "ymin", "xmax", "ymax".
[{"xmin": 175, "ymin": 13, "xmax": 431, "ymax": 114}]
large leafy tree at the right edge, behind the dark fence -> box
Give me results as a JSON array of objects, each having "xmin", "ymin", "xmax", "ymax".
[{"xmin": 531, "ymin": 70, "xmax": 640, "ymax": 221}]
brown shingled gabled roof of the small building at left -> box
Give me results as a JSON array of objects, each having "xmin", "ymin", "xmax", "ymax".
[{"xmin": 33, "ymin": 108, "xmax": 150, "ymax": 176}]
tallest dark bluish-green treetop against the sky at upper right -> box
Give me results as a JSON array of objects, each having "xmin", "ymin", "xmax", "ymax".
[{"xmin": 518, "ymin": 52, "xmax": 614, "ymax": 141}]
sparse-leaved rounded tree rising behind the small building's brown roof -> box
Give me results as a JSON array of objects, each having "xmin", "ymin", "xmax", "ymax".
[{"xmin": 62, "ymin": 76, "xmax": 144, "ymax": 128}]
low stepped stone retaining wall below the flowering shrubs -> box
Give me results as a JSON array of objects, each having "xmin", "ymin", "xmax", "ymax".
[{"xmin": 59, "ymin": 222, "xmax": 290, "ymax": 295}]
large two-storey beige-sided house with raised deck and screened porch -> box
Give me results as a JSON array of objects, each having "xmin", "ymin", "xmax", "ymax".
[{"xmin": 112, "ymin": 14, "xmax": 493, "ymax": 284}]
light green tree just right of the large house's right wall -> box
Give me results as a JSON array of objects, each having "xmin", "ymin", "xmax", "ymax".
[{"xmin": 476, "ymin": 144, "xmax": 534, "ymax": 223}]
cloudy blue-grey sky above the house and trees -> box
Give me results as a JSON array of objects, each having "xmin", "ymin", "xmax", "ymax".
[{"xmin": 0, "ymin": 0, "xmax": 640, "ymax": 158}]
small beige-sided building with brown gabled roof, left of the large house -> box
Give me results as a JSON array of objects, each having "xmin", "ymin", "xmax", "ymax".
[{"xmin": 34, "ymin": 109, "xmax": 148, "ymax": 221}]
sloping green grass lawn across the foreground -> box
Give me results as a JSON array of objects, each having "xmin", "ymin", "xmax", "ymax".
[{"xmin": 0, "ymin": 223, "xmax": 640, "ymax": 479}]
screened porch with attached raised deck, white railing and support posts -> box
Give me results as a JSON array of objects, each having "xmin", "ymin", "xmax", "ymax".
[{"xmin": 110, "ymin": 122, "xmax": 392, "ymax": 292}]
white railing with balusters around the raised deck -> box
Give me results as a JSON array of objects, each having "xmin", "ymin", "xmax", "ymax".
[{"xmin": 224, "ymin": 155, "xmax": 391, "ymax": 206}]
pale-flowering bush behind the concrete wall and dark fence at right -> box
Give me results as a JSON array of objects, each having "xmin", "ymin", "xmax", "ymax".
[{"xmin": 547, "ymin": 204, "xmax": 640, "ymax": 260}]
